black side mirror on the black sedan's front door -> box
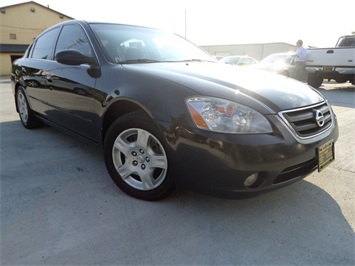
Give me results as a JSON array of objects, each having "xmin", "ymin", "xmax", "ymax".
[{"xmin": 55, "ymin": 50, "xmax": 96, "ymax": 66}]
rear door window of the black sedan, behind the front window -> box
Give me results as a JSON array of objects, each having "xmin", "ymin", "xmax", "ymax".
[{"xmin": 31, "ymin": 28, "xmax": 59, "ymax": 60}]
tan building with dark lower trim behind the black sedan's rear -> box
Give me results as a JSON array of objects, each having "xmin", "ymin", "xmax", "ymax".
[{"xmin": 0, "ymin": 1, "xmax": 72, "ymax": 75}]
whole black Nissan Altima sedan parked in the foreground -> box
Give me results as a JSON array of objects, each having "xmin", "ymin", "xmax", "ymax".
[{"xmin": 12, "ymin": 20, "xmax": 338, "ymax": 200}]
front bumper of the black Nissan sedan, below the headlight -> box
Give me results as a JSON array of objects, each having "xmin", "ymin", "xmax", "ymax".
[{"xmin": 161, "ymin": 109, "xmax": 339, "ymax": 198}]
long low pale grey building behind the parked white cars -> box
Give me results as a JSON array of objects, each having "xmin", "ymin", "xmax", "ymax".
[{"xmin": 201, "ymin": 42, "xmax": 296, "ymax": 60}]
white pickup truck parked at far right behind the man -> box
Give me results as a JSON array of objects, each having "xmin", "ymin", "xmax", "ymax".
[{"xmin": 305, "ymin": 35, "xmax": 355, "ymax": 88}]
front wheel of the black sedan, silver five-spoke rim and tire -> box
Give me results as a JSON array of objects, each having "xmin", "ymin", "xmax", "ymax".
[{"xmin": 104, "ymin": 112, "xmax": 174, "ymax": 200}]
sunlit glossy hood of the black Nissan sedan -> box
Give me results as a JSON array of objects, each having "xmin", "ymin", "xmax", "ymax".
[{"xmin": 125, "ymin": 62, "xmax": 324, "ymax": 112}]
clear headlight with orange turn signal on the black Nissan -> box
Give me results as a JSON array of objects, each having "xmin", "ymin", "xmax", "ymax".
[{"xmin": 186, "ymin": 97, "xmax": 272, "ymax": 134}]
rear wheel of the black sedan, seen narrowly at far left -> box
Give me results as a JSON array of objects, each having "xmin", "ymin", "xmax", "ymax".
[{"xmin": 16, "ymin": 87, "xmax": 43, "ymax": 129}]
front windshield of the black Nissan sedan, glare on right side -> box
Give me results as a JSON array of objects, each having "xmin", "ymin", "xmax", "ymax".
[{"xmin": 90, "ymin": 23, "xmax": 216, "ymax": 64}]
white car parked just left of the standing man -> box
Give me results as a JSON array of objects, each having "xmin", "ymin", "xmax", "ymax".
[{"xmin": 252, "ymin": 53, "xmax": 295, "ymax": 77}]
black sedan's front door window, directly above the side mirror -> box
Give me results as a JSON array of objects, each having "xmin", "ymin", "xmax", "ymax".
[{"xmin": 55, "ymin": 25, "xmax": 93, "ymax": 56}]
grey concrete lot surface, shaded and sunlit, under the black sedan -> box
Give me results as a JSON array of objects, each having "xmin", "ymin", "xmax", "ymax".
[{"xmin": 0, "ymin": 80, "xmax": 355, "ymax": 265}]
